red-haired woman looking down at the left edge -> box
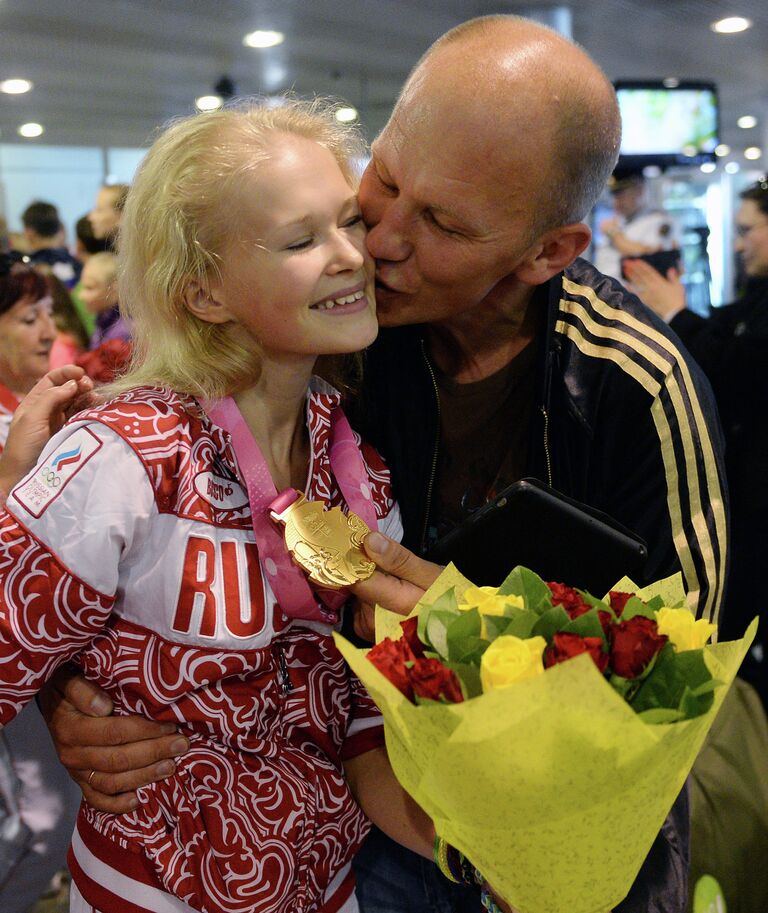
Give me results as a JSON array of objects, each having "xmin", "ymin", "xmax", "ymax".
[{"xmin": 0, "ymin": 254, "xmax": 78, "ymax": 913}]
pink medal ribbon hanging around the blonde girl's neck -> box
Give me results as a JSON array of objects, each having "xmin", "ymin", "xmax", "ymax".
[{"xmin": 202, "ymin": 396, "xmax": 377, "ymax": 624}]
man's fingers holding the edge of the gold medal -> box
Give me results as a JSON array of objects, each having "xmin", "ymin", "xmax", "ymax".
[{"xmin": 351, "ymin": 533, "xmax": 443, "ymax": 616}]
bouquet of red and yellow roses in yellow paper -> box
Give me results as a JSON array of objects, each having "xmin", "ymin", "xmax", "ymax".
[{"xmin": 337, "ymin": 567, "xmax": 756, "ymax": 913}]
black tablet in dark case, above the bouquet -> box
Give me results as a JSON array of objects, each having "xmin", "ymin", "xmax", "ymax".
[{"xmin": 425, "ymin": 479, "xmax": 648, "ymax": 598}]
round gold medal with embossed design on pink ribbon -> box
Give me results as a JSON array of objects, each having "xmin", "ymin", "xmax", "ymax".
[{"xmin": 270, "ymin": 491, "xmax": 376, "ymax": 589}]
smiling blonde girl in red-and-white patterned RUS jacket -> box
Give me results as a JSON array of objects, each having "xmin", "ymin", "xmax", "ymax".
[{"xmin": 0, "ymin": 103, "xmax": 434, "ymax": 913}]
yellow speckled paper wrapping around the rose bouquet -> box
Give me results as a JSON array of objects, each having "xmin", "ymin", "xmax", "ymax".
[{"xmin": 335, "ymin": 568, "xmax": 757, "ymax": 913}]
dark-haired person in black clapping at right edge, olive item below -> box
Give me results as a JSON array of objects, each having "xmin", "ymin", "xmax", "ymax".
[{"xmin": 626, "ymin": 179, "xmax": 768, "ymax": 913}]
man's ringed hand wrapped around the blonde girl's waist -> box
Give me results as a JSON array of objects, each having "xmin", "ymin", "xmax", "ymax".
[{"xmin": 40, "ymin": 667, "xmax": 189, "ymax": 813}]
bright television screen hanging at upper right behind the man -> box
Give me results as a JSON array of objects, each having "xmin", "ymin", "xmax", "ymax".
[{"xmin": 616, "ymin": 82, "xmax": 720, "ymax": 165}]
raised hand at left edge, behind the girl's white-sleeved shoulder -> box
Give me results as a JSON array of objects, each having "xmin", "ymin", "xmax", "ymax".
[{"xmin": 0, "ymin": 365, "xmax": 93, "ymax": 494}]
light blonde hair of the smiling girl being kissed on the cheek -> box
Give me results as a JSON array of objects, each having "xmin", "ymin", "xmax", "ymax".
[{"xmin": 107, "ymin": 99, "xmax": 366, "ymax": 399}]
